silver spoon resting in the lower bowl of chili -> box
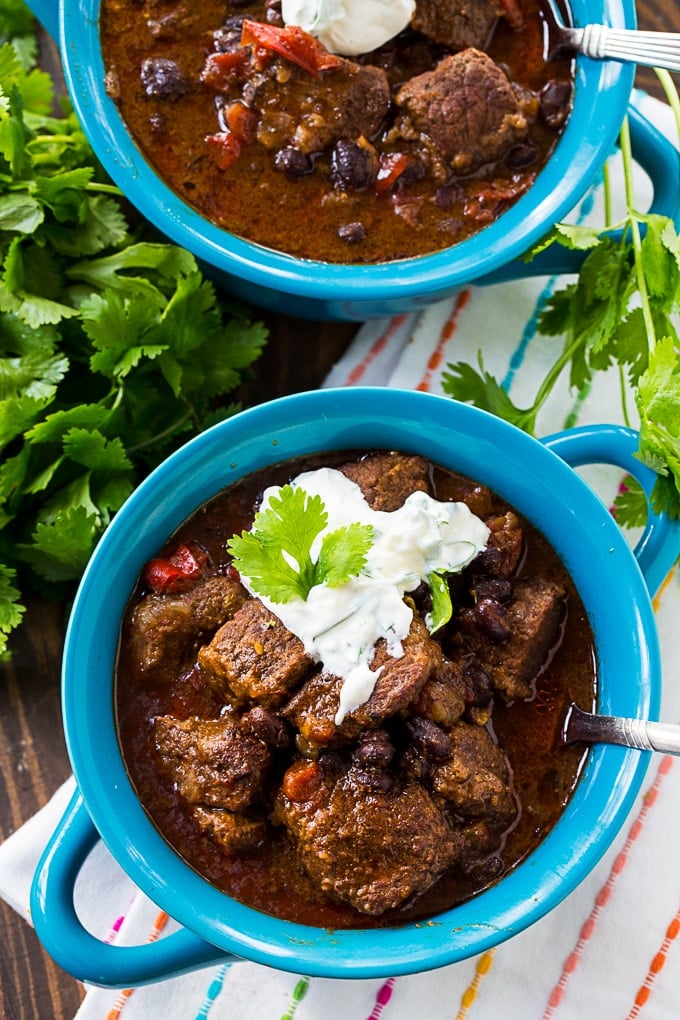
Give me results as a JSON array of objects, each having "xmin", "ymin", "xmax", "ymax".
[{"xmin": 562, "ymin": 705, "xmax": 680, "ymax": 755}]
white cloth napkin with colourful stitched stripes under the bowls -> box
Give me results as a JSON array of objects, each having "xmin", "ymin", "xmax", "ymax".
[{"xmin": 0, "ymin": 91, "xmax": 680, "ymax": 1020}]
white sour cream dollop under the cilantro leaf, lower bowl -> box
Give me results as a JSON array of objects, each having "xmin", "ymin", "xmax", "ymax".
[{"xmin": 235, "ymin": 468, "xmax": 489, "ymax": 725}]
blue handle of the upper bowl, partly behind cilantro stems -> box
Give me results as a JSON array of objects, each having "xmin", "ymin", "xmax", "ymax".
[{"xmin": 475, "ymin": 103, "xmax": 680, "ymax": 286}]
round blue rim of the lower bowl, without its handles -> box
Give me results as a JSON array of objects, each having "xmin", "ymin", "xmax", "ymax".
[{"xmin": 62, "ymin": 388, "xmax": 661, "ymax": 978}]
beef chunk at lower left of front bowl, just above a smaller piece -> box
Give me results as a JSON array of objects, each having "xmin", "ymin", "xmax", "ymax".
[{"xmin": 154, "ymin": 714, "xmax": 271, "ymax": 811}]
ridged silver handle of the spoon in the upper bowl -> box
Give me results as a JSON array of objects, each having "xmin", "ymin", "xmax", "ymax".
[{"xmin": 563, "ymin": 24, "xmax": 680, "ymax": 71}]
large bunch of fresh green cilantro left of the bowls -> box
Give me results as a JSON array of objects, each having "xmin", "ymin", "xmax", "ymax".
[{"xmin": 0, "ymin": 0, "xmax": 266, "ymax": 656}]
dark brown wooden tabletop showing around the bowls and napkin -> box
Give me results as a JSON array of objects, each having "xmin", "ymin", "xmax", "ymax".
[{"xmin": 0, "ymin": 0, "xmax": 680, "ymax": 1020}]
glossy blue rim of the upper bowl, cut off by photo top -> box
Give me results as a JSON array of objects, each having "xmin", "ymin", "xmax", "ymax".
[{"xmin": 59, "ymin": 0, "xmax": 636, "ymax": 303}]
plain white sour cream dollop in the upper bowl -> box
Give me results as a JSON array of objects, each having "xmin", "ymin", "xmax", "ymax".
[{"xmin": 281, "ymin": 0, "xmax": 416, "ymax": 56}]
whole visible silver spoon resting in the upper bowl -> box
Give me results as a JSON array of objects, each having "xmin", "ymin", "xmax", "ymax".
[{"xmin": 545, "ymin": 0, "xmax": 680, "ymax": 71}]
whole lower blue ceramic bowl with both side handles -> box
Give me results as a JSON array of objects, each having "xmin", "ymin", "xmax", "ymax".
[{"xmin": 32, "ymin": 388, "xmax": 680, "ymax": 986}]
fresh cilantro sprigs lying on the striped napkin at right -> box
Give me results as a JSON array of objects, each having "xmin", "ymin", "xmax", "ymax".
[{"xmin": 442, "ymin": 70, "xmax": 680, "ymax": 526}]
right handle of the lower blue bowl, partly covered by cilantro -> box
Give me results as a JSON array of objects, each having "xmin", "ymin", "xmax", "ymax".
[{"xmin": 541, "ymin": 425, "xmax": 680, "ymax": 595}]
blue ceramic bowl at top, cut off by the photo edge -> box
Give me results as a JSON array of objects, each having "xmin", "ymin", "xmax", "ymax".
[{"xmin": 28, "ymin": 0, "xmax": 680, "ymax": 320}]
